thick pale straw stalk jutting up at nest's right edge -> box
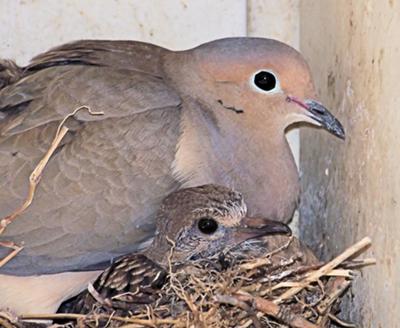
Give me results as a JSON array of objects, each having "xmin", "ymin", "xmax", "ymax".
[{"xmin": 274, "ymin": 237, "xmax": 371, "ymax": 304}]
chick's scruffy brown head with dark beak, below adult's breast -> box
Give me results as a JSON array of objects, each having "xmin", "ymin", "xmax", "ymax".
[{"xmin": 148, "ymin": 185, "xmax": 290, "ymax": 265}]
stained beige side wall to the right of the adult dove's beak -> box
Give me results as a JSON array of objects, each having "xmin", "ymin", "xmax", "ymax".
[{"xmin": 300, "ymin": 0, "xmax": 400, "ymax": 328}]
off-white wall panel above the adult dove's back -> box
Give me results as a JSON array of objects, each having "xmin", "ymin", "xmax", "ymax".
[{"xmin": 0, "ymin": 0, "xmax": 247, "ymax": 63}]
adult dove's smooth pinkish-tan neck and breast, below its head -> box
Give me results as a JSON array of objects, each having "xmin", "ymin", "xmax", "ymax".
[{"xmin": 173, "ymin": 101, "xmax": 299, "ymax": 222}]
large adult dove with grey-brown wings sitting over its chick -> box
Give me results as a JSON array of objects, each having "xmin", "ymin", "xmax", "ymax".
[{"xmin": 0, "ymin": 38, "xmax": 344, "ymax": 310}]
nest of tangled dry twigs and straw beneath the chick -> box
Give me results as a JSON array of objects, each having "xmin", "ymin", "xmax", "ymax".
[{"xmin": 0, "ymin": 236, "xmax": 374, "ymax": 328}]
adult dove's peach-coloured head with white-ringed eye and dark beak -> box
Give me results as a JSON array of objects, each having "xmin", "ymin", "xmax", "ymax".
[{"xmin": 167, "ymin": 38, "xmax": 345, "ymax": 138}]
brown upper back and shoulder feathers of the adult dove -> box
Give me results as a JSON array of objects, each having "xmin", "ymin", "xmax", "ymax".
[{"xmin": 0, "ymin": 41, "xmax": 181, "ymax": 136}]
